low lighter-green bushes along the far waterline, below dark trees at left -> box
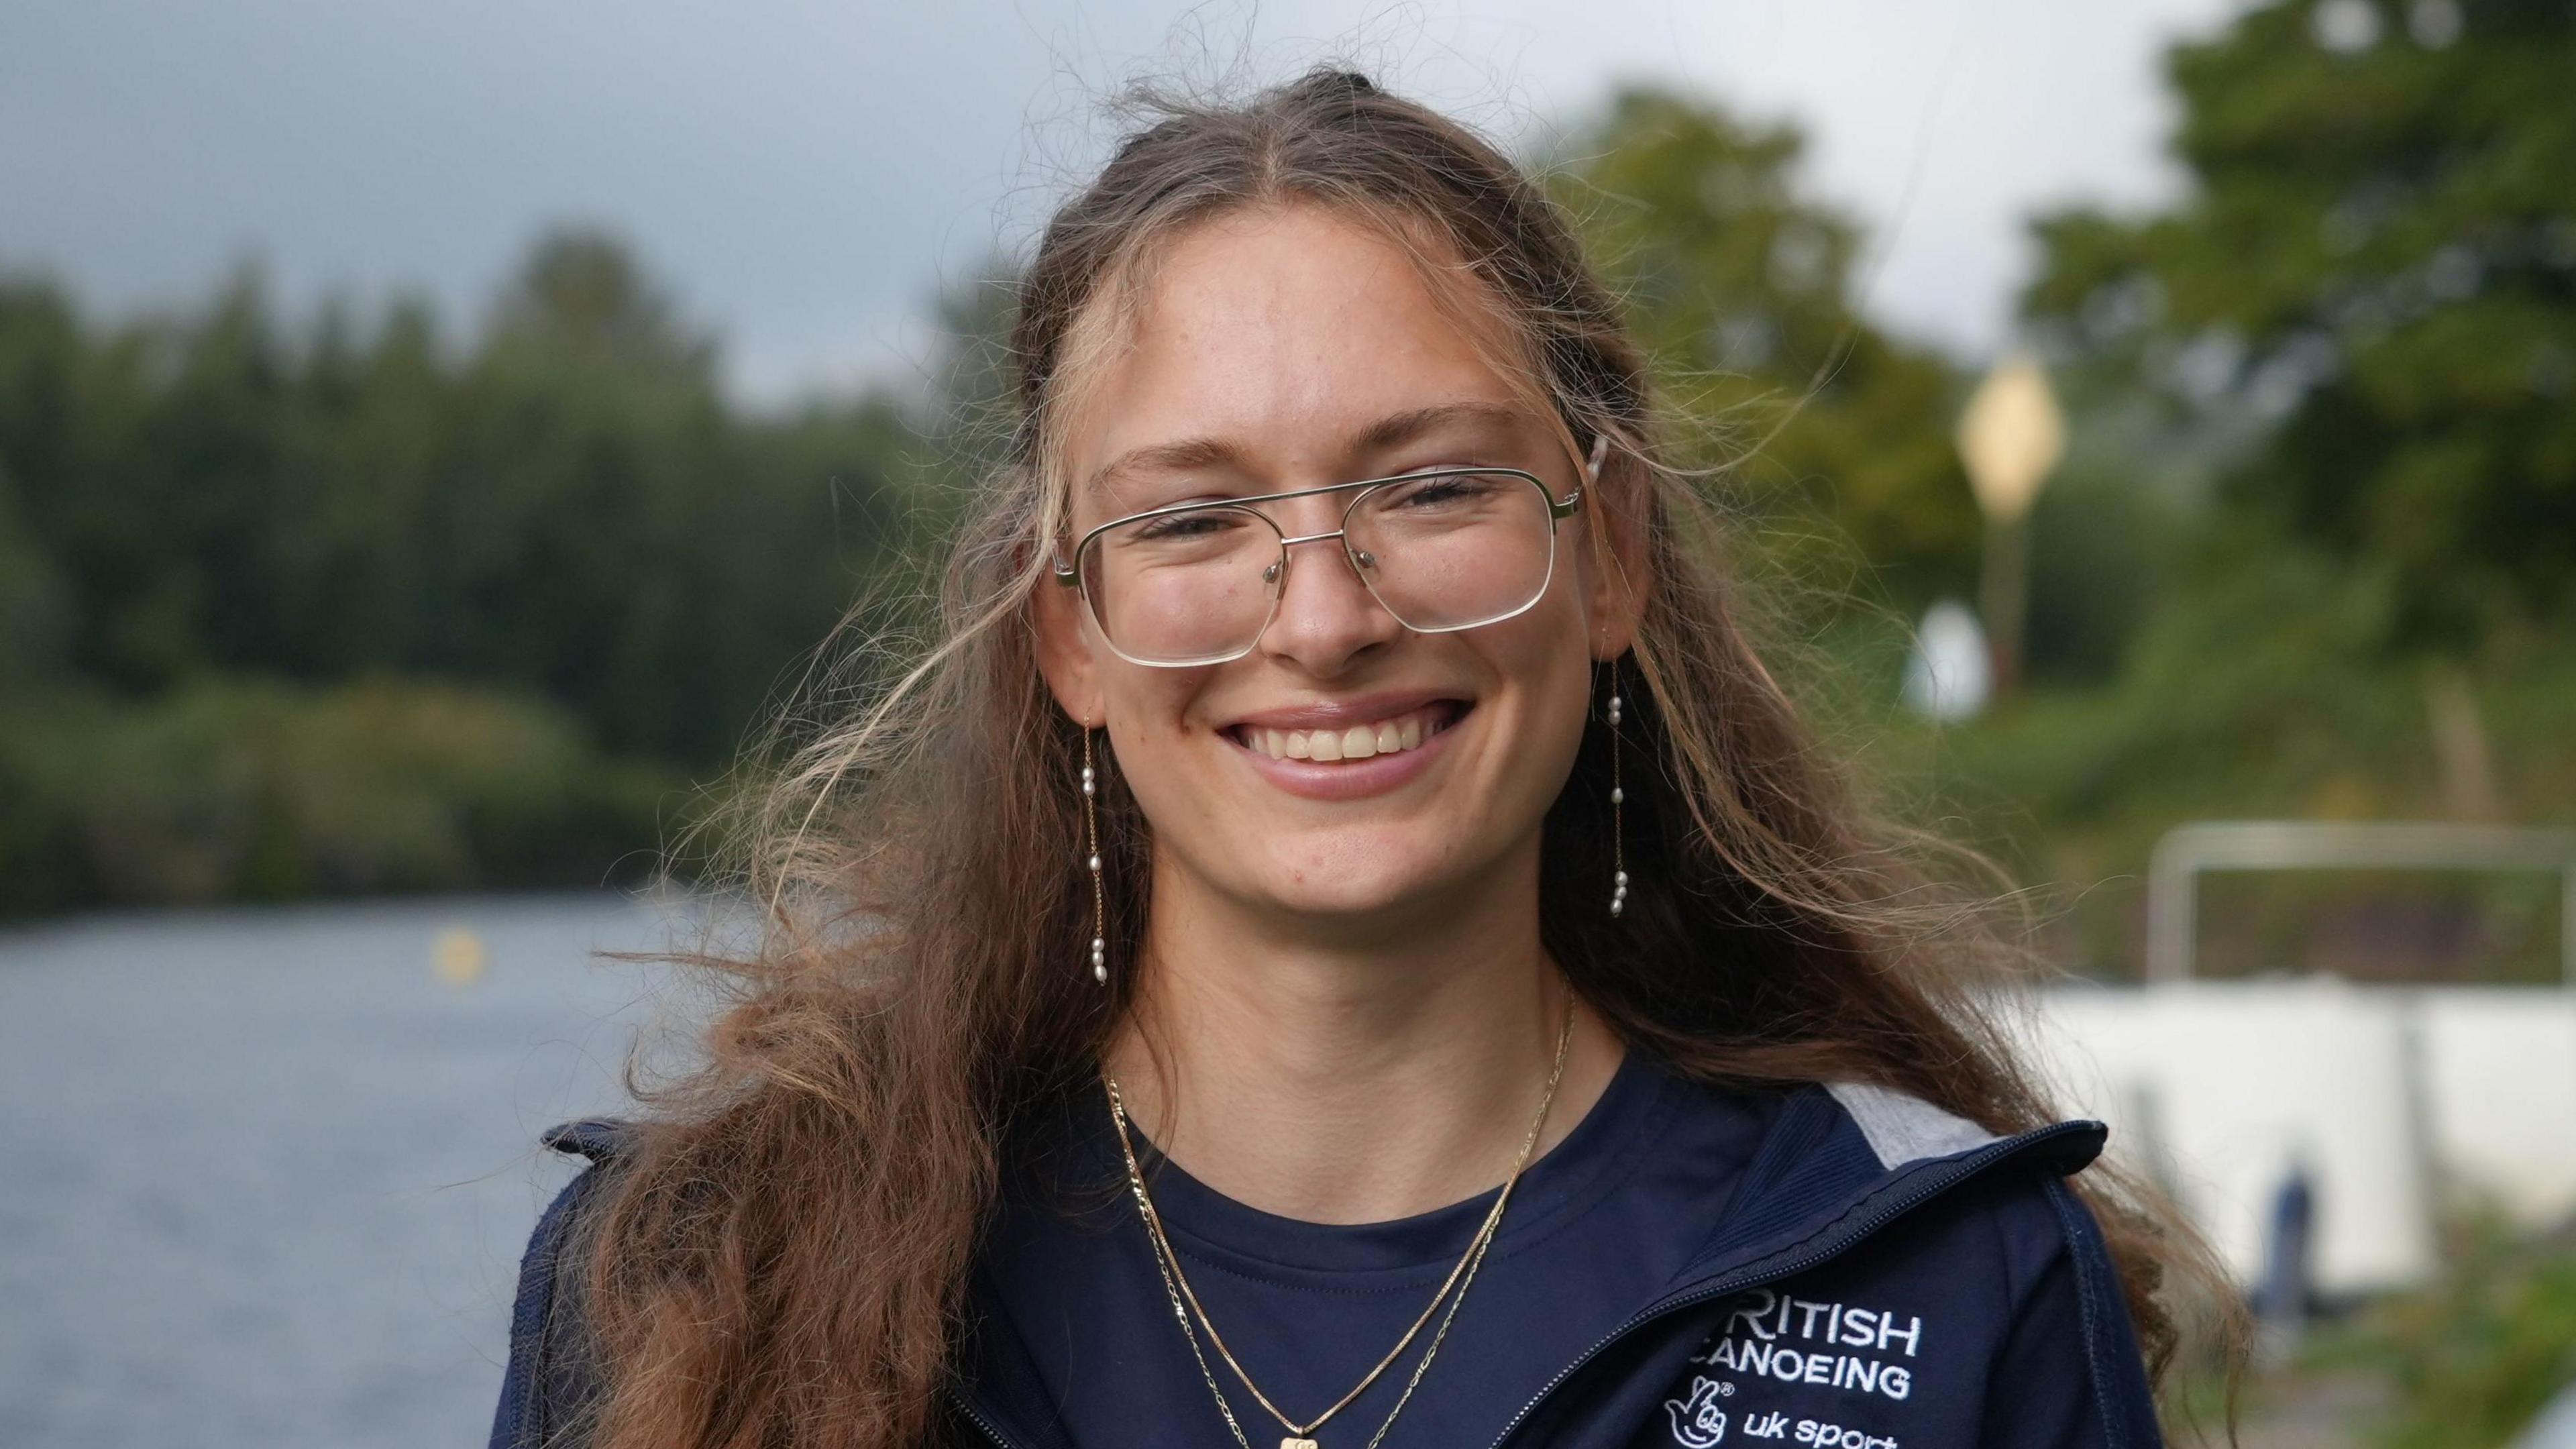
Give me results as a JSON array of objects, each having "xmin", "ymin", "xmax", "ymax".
[{"xmin": 0, "ymin": 681, "xmax": 683, "ymax": 913}]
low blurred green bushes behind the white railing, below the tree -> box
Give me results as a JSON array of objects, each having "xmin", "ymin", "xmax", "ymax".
[{"xmin": 1870, "ymin": 536, "xmax": 2576, "ymax": 982}]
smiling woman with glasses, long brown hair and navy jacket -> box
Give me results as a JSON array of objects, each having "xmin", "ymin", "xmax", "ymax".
[{"xmin": 494, "ymin": 72, "xmax": 2215, "ymax": 1449}]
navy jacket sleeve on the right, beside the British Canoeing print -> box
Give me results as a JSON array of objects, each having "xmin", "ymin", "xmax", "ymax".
[{"xmin": 1978, "ymin": 1178, "xmax": 2164, "ymax": 1449}]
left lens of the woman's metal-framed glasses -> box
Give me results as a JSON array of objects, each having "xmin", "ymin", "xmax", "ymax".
[{"xmin": 1082, "ymin": 508, "xmax": 1280, "ymax": 665}]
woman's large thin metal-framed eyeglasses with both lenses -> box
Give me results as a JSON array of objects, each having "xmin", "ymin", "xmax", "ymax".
[{"xmin": 1056, "ymin": 467, "xmax": 1585, "ymax": 667}]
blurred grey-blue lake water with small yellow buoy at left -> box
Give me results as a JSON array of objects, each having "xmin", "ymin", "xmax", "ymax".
[{"xmin": 0, "ymin": 895, "xmax": 706, "ymax": 1449}]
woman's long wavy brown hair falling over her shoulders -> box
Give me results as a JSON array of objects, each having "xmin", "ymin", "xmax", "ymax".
[{"xmin": 585, "ymin": 70, "xmax": 2198, "ymax": 1449}]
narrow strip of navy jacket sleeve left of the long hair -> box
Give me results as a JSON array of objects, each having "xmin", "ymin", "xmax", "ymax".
[{"xmin": 492, "ymin": 1124, "xmax": 623, "ymax": 1449}]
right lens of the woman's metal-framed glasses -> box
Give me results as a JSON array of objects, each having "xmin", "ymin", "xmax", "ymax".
[{"xmin": 1344, "ymin": 472, "xmax": 1556, "ymax": 632}]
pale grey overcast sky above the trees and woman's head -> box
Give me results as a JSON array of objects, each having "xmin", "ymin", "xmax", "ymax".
[{"xmin": 0, "ymin": 0, "xmax": 2236, "ymax": 400}]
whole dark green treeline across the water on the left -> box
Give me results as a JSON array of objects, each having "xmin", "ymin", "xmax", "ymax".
[{"xmin": 0, "ymin": 235, "xmax": 968, "ymax": 910}]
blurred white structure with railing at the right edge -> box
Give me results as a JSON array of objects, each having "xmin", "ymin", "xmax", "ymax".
[{"xmin": 2033, "ymin": 822, "xmax": 2576, "ymax": 1294}]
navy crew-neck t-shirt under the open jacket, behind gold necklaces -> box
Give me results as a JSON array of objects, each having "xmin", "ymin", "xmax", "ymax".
[{"xmin": 976, "ymin": 1052, "xmax": 1778, "ymax": 1449}]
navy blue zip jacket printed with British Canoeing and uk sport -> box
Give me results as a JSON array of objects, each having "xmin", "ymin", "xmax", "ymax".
[{"xmin": 492, "ymin": 1083, "xmax": 2161, "ymax": 1449}]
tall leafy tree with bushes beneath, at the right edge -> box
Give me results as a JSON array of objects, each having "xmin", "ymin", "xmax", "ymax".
[{"xmin": 1947, "ymin": 0, "xmax": 2576, "ymax": 979}]
